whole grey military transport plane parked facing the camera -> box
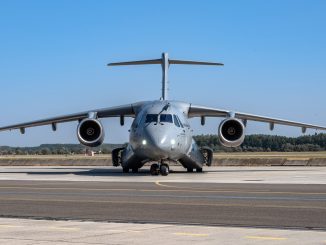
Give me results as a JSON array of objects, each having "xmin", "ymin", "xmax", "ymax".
[{"xmin": 0, "ymin": 53, "xmax": 326, "ymax": 175}]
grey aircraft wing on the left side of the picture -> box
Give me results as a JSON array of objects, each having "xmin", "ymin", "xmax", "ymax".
[{"xmin": 0, "ymin": 102, "xmax": 144, "ymax": 133}]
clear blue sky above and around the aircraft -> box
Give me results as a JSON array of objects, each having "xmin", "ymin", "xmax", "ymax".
[{"xmin": 0, "ymin": 0, "xmax": 326, "ymax": 146}]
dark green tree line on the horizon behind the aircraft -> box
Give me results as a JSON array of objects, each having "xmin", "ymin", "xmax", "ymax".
[{"xmin": 0, "ymin": 134, "xmax": 326, "ymax": 155}]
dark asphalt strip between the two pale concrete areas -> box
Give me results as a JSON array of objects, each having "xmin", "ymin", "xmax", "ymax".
[{"xmin": 0, "ymin": 179, "xmax": 326, "ymax": 230}]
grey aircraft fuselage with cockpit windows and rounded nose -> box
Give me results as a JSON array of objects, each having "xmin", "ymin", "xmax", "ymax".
[{"xmin": 122, "ymin": 100, "xmax": 204, "ymax": 171}]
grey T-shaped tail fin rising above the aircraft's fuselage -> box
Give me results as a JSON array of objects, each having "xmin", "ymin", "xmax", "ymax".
[{"xmin": 108, "ymin": 53, "xmax": 224, "ymax": 100}]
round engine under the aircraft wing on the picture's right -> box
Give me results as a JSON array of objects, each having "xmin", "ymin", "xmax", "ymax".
[{"xmin": 218, "ymin": 118, "xmax": 245, "ymax": 147}]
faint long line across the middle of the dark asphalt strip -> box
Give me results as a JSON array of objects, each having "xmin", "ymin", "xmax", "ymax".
[{"xmin": 0, "ymin": 198, "xmax": 326, "ymax": 210}]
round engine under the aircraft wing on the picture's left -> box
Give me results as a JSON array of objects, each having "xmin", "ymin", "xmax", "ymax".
[{"xmin": 77, "ymin": 118, "xmax": 104, "ymax": 147}]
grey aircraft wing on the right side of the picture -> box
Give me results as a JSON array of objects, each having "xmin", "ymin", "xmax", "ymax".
[{"xmin": 188, "ymin": 104, "xmax": 326, "ymax": 132}]
